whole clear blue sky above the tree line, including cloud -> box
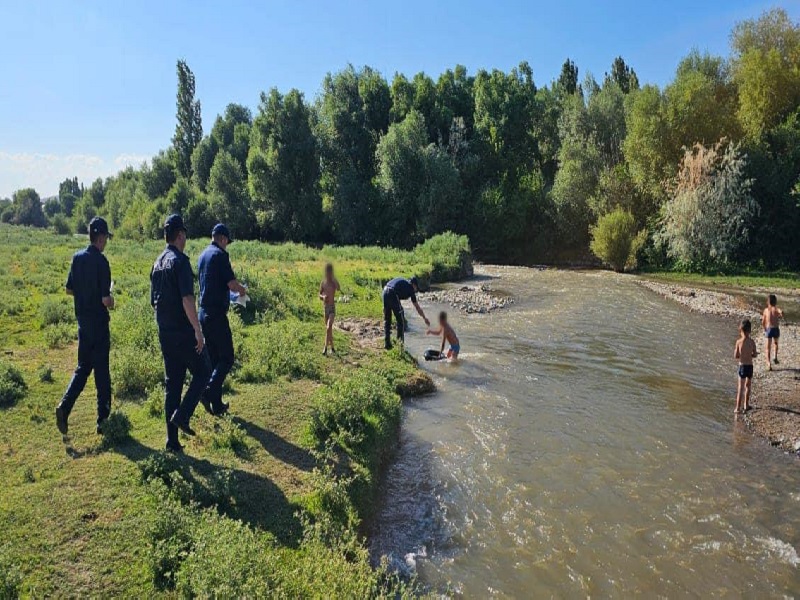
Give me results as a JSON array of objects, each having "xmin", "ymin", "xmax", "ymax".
[{"xmin": 0, "ymin": 0, "xmax": 800, "ymax": 197}]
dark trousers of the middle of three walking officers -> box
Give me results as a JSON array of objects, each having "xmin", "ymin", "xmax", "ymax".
[{"xmin": 158, "ymin": 330, "xmax": 208, "ymax": 443}]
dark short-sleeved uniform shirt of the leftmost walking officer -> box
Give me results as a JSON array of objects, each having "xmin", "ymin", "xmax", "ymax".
[{"xmin": 66, "ymin": 246, "xmax": 111, "ymax": 323}]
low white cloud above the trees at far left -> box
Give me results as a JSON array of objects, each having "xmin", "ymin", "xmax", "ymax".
[{"xmin": 0, "ymin": 151, "xmax": 149, "ymax": 198}]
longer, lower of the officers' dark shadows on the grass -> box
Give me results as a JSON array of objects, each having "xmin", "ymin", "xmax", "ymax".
[{"xmin": 110, "ymin": 438, "xmax": 303, "ymax": 548}]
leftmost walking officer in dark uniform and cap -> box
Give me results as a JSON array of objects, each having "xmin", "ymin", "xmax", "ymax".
[{"xmin": 56, "ymin": 217, "xmax": 114, "ymax": 435}]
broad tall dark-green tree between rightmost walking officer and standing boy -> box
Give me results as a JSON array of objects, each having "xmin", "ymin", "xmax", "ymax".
[{"xmin": 247, "ymin": 88, "xmax": 324, "ymax": 241}]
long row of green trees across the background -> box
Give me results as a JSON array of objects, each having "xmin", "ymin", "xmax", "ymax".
[{"xmin": 6, "ymin": 9, "xmax": 800, "ymax": 268}]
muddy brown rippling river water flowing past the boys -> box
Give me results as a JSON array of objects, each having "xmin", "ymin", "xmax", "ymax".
[{"xmin": 372, "ymin": 268, "xmax": 800, "ymax": 598}]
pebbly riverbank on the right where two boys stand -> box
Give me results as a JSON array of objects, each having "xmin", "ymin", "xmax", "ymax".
[{"xmin": 638, "ymin": 279, "xmax": 800, "ymax": 454}]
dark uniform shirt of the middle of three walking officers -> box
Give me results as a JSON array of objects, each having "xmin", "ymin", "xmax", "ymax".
[{"xmin": 150, "ymin": 244, "xmax": 194, "ymax": 333}]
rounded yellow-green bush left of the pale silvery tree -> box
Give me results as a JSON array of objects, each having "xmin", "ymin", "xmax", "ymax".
[{"xmin": 589, "ymin": 208, "xmax": 647, "ymax": 273}]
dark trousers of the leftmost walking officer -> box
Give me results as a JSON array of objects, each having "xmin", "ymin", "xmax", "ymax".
[{"xmin": 60, "ymin": 320, "xmax": 111, "ymax": 423}]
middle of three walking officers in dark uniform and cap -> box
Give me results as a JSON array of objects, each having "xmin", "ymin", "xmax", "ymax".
[{"xmin": 150, "ymin": 215, "xmax": 208, "ymax": 452}]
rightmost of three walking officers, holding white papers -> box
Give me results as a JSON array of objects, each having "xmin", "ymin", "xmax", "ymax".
[{"xmin": 197, "ymin": 223, "xmax": 247, "ymax": 415}]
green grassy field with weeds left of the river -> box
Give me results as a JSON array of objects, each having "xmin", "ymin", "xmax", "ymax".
[{"xmin": 0, "ymin": 225, "xmax": 467, "ymax": 598}]
